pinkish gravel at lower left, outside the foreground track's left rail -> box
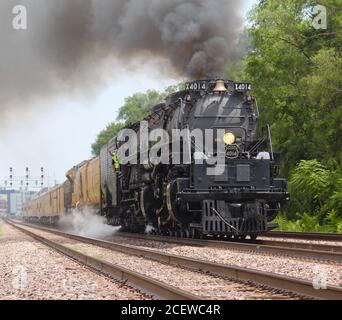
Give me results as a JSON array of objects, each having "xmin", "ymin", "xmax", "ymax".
[{"xmin": 0, "ymin": 221, "xmax": 151, "ymax": 300}]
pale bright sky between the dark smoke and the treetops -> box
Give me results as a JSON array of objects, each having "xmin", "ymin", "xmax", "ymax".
[{"xmin": 0, "ymin": 0, "xmax": 257, "ymax": 187}]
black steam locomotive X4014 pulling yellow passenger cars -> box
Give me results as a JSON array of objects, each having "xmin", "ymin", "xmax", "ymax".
[{"xmin": 23, "ymin": 80, "xmax": 289, "ymax": 239}]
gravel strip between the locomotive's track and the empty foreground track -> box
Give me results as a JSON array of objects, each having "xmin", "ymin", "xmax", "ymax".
[{"xmin": 106, "ymin": 236, "xmax": 342, "ymax": 286}]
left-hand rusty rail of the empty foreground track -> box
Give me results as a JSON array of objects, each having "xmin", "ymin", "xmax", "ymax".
[{"xmin": 7, "ymin": 220, "xmax": 202, "ymax": 300}]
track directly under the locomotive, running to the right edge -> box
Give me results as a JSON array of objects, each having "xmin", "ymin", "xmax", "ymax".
[{"xmin": 113, "ymin": 233, "xmax": 342, "ymax": 263}]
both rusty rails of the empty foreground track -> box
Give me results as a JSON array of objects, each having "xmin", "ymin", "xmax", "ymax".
[{"xmin": 9, "ymin": 222, "xmax": 342, "ymax": 300}]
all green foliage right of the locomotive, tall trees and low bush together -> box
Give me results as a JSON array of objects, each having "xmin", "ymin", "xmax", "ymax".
[{"xmin": 243, "ymin": 0, "xmax": 342, "ymax": 232}]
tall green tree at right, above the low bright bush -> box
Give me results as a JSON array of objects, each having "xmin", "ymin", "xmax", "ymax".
[{"xmin": 245, "ymin": 0, "xmax": 342, "ymax": 175}]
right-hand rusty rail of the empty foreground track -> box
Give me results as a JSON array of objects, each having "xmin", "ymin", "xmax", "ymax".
[{"xmin": 7, "ymin": 220, "xmax": 342, "ymax": 300}]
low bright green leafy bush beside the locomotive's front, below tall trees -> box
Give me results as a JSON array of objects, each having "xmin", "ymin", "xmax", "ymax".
[{"xmin": 276, "ymin": 160, "xmax": 342, "ymax": 233}]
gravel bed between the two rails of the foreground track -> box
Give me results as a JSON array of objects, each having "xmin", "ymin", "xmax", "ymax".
[{"xmin": 11, "ymin": 227, "xmax": 302, "ymax": 300}]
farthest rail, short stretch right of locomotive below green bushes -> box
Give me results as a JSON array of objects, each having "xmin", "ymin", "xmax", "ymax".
[{"xmin": 263, "ymin": 231, "xmax": 342, "ymax": 241}]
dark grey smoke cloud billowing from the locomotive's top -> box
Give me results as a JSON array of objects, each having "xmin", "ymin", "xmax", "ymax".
[{"xmin": 0, "ymin": 0, "xmax": 243, "ymax": 118}]
